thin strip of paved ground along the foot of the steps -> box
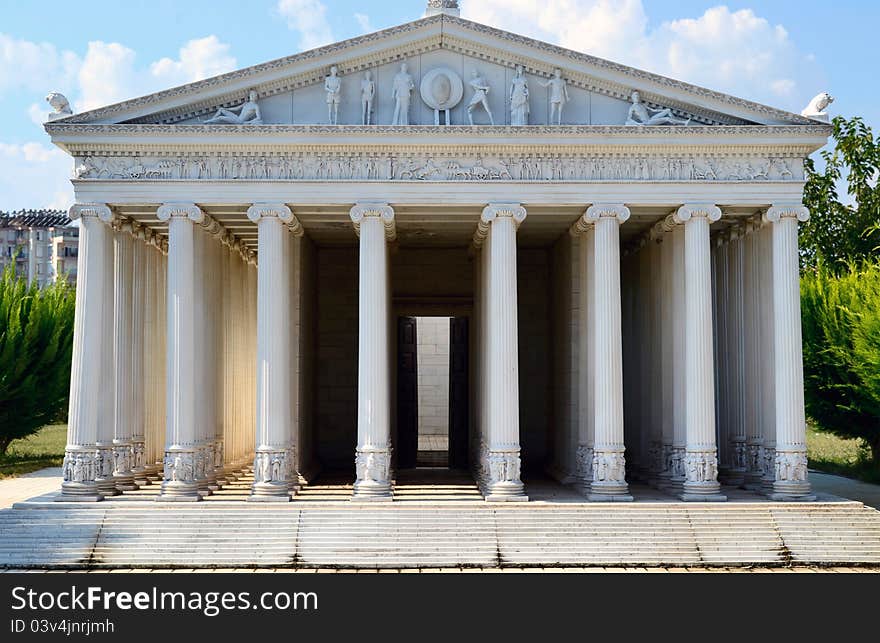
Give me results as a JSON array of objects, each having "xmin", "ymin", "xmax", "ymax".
[{"xmin": 0, "ymin": 567, "xmax": 880, "ymax": 574}]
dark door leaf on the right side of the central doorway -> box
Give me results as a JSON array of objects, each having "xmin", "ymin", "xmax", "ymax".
[{"xmin": 449, "ymin": 317, "xmax": 470, "ymax": 469}]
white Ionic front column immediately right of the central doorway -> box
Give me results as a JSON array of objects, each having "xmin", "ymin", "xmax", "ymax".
[{"xmin": 474, "ymin": 203, "xmax": 528, "ymax": 502}]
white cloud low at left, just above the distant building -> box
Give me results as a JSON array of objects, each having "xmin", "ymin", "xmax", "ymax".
[{"xmin": 0, "ymin": 142, "xmax": 73, "ymax": 210}]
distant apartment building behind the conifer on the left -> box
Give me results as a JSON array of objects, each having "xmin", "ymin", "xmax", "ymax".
[{"xmin": 0, "ymin": 210, "xmax": 79, "ymax": 286}]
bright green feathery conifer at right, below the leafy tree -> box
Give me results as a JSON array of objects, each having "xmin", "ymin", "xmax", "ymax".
[{"xmin": 801, "ymin": 262, "xmax": 880, "ymax": 469}]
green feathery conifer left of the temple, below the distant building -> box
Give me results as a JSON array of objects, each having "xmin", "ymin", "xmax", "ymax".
[{"xmin": 0, "ymin": 261, "xmax": 75, "ymax": 455}]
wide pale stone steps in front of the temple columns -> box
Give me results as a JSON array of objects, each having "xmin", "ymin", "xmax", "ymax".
[{"xmin": 0, "ymin": 502, "xmax": 880, "ymax": 567}]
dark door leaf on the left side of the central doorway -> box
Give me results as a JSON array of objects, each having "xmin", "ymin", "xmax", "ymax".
[{"xmin": 397, "ymin": 317, "xmax": 419, "ymax": 469}]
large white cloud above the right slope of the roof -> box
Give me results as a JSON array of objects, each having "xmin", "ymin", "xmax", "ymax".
[{"xmin": 463, "ymin": 0, "xmax": 822, "ymax": 111}]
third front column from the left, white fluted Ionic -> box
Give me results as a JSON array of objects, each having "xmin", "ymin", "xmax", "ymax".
[{"xmin": 248, "ymin": 204, "xmax": 302, "ymax": 502}]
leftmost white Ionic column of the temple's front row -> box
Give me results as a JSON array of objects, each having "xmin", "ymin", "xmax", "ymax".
[{"xmin": 58, "ymin": 203, "xmax": 113, "ymax": 502}]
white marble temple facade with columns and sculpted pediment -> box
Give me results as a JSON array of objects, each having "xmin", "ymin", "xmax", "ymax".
[{"xmin": 47, "ymin": 2, "xmax": 829, "ymax": 502}]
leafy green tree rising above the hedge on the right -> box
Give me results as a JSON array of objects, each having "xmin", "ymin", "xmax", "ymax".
[{"xmin": 800, "ymin": 116, "xmax": 880, "ymax": 272}]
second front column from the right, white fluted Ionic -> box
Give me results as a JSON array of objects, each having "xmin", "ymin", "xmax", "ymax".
[{"xmin": 676, "ymin": 204, "xmax": 726, "ymax": 502}]
